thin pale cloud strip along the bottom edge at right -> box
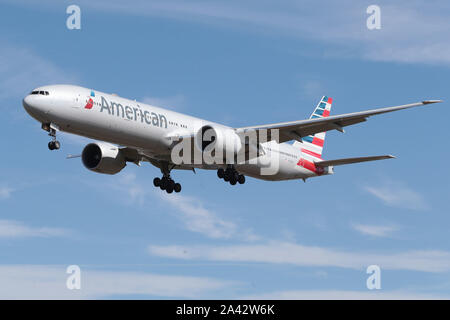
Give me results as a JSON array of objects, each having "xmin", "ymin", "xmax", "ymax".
[{"xmin": 242, "ymin": 290, "xmax": 449, "ymax": 300}]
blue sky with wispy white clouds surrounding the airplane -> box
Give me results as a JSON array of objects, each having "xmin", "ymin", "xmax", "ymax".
[{"xmin": 0, "ymin": 0, "xmax": 450, "ymax": 299}]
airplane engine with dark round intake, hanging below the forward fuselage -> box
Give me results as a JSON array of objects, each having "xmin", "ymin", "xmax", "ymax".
[{"xmin": 81, "ymin": 143, "xmax": 126, "ymax": 174}]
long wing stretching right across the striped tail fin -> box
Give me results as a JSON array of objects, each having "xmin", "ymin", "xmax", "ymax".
[{"xmin": 236, "ymin": 100, "xmax": 442, "ymax": 143}]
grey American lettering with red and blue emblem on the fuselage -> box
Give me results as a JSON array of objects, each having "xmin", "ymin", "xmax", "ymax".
[{"xmin": 85, "ymin": 93, "xmax": 167, "ymax": 128}]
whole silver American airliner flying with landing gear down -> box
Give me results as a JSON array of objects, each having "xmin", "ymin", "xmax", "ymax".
[{"xmin": 22, "ymin": 84, "xmax": 442, "ymax": 193}]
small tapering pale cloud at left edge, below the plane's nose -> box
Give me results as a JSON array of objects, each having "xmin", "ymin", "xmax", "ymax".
[{"xmin": 0, "ymin": 220, "xmax": 69, "ymax": 238}]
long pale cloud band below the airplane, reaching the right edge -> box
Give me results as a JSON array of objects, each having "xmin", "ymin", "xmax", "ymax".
[{"xmin": 148, "ymin": 242, "xmax": 450, "ymax": 272}]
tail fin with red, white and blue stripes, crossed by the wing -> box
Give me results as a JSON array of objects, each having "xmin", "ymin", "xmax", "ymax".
[{"xmin": 293, "ymin": 96, "xmax": 333, "ymax": 160}]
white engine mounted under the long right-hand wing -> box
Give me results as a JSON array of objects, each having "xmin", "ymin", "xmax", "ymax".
[{"xmin": 195, "ymin": 125, "xmax": 242, "ymax": 155}]
